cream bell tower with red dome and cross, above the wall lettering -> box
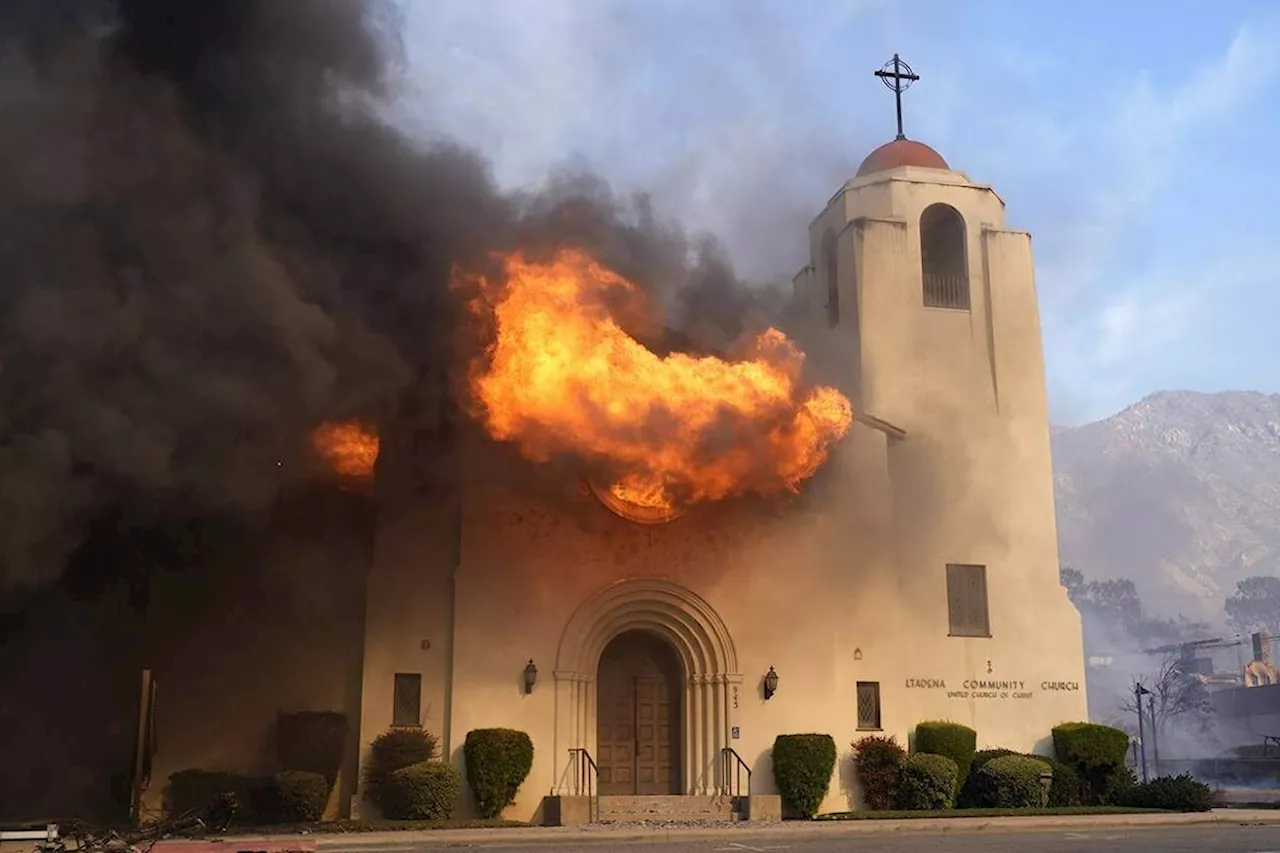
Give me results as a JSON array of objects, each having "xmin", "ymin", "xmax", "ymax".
[{"xmin": 794, "ymin": 55, "xmax": 1083, "ymax": 654}]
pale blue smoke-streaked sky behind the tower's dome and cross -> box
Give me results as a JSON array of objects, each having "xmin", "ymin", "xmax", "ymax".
[{"xmin": 399, "ymin": 0, "xmax": 1280, "ymax": 424}]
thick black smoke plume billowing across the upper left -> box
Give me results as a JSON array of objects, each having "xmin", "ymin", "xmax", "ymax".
[{"xmin": 0, "ymin": 0, "xmax": 778, "ymax": 601}]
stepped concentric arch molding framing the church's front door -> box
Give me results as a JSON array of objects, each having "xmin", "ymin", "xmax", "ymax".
[{"xmin": 554, "ymin": 578, "xmax": 742, "ymax": 794}]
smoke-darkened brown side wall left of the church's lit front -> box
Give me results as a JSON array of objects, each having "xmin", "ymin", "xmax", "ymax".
[{"xmin": 143, "ymin": 494, "xmax": 370, "ymax": 813}]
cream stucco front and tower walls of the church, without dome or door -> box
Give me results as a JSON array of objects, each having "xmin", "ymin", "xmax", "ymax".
[{"xmin": 352, "ymin": 144, "xmax": 1087, "ymax": 820}]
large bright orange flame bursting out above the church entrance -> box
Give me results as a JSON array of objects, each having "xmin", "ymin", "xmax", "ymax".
[{"xmin": 460, "ymin": 250, "xmax": 852, "ymax": 508}]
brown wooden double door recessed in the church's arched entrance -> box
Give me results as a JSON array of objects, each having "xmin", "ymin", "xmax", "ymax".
[{"xmin": 595, "ymin": 630, "xmax": 684, "ymax": 794}]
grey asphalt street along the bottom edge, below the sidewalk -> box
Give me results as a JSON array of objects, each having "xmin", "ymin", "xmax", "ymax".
[{"xmin": 386, "ymin": 826, "xmax": 1280, "ymax": 853}]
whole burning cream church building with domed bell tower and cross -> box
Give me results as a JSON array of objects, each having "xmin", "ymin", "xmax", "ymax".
[{"xmin": 82, "ymin": 58, "xmax": 1088, "ymax": 822}]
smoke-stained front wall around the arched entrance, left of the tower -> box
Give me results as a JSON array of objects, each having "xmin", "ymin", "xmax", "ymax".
[{"xmin": 435, "ymin": 427, "xmax": 901, "ymax": 820}]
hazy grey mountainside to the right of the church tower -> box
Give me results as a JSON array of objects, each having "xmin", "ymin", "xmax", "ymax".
[{"xmin": 1052, "ymin": 391, "xmax": 1280, "ymax": 625}]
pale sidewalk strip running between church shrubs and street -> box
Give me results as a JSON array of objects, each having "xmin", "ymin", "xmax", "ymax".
[{"xmin": 192, "ymin": 808, "xmax": 1280, "ymax": 853}]
